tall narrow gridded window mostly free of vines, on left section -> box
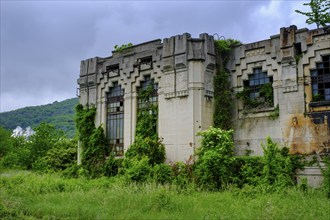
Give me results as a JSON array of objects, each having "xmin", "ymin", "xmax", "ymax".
[{"xmin": 107, "ymin": 82, "xmax": 124, "ymax": 156}]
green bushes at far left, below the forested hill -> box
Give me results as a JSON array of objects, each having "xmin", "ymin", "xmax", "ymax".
[{"xmin": 0, "ymin": 123, "xmax": 77, "ymax": 172}]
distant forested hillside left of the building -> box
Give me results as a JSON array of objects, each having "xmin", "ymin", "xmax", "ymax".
[{"xmin": 0, "ymin": 98, "xmax": 78, "ymax": 137}]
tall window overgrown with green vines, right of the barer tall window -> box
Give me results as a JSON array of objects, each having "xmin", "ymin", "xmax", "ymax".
[{"xmin": 136, "ymin": 76, "xmax": 158, "ymax": 138}]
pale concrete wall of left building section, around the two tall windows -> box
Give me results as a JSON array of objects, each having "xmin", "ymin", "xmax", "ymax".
[{"xmin": 78, "ymin": 33, "xmax": 215, "ymax": 162}]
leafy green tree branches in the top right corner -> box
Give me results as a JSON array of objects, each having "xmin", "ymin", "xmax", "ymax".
[{"xmin": 295, "ymin": 0, "xmax": 330, "ymax": 28}]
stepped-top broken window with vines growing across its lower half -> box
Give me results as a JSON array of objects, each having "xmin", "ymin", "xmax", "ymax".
[{"xmin": 237, "ymin": 68, "xmax": 274, "ymax": 108}]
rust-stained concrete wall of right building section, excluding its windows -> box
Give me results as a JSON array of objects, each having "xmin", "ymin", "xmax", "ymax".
[{"xmin": 228, "ymin": 26, "xmax": 330, "ymax": 155}]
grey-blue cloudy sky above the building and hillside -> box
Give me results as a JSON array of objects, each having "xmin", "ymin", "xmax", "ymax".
[{"xmin": 0, "ymin": 0, "xmax": 314, "ymax": 112}]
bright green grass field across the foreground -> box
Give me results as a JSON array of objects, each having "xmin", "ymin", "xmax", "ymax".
[{"xmin": 0, "ymin": 171, "xmax": 330, "ymax": 220}]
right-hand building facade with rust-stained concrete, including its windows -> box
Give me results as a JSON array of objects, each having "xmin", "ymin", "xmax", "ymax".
[{"xmin": 228, "ymin": 26, "xmax": 330, "ymax": 155}]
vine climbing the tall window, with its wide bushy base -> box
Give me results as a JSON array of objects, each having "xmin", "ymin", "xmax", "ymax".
[{"xmin": 122, "ymin": 83, "xmax": 169, "ymax": 182}]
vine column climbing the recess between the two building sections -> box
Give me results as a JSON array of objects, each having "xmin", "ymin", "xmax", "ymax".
[{"xmin": 213, "ymin": 39, "xmax": 240, "ymax": 130}]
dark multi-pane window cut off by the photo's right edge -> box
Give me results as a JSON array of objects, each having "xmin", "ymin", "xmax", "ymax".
[{"xmin": 311, "ymin": 55, "xmax": 330, "ymax": 102}]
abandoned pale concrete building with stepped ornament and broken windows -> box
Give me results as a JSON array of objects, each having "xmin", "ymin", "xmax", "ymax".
[{"xmin": 78, "ymin": 26, "xmax": 330, "ymax": 167}]
